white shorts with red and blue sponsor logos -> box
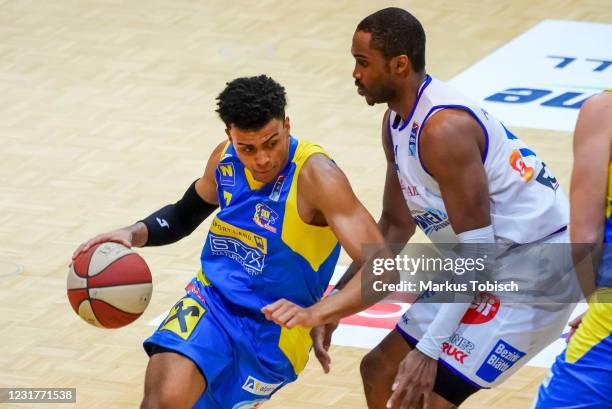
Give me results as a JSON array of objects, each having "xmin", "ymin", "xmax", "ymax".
[{"xmin": 396, "ymin": 232, "xmax": 577, "ymax": 388}]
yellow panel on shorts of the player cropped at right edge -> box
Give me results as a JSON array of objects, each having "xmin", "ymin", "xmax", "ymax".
[{"xmin": 565, "ymin": 288, "xmax": 612, "ymax": 363}]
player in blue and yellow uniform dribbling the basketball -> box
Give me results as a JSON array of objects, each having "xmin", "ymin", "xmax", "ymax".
[{"xmin": 73, "ymin": 75, "xmax": 383, "ymax": 409}]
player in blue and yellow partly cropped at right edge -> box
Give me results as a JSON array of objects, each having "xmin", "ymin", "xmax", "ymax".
[{"xmin": 535, "ymin": 90, "xmax": 612, "ymax": 409}]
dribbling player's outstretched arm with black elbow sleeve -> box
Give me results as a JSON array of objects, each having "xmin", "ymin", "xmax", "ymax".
[{"xmin": 72, "ymin": 142, "xmax": 225, "ymax": 260}]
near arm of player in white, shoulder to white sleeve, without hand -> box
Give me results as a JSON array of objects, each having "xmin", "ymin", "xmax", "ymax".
[{"xmin": 417, "ymin": 109, "xmax": 494, "ymax": 359}]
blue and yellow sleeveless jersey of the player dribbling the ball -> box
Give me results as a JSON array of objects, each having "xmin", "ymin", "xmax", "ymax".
[{"xmin": 198, "ymin": 137, "xmax": 340, "ymax": 311}]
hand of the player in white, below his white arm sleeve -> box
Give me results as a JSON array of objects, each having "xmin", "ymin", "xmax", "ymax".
[{"xmin": 387, "ymin": 349, "xmax": 438, "ymax": 409}]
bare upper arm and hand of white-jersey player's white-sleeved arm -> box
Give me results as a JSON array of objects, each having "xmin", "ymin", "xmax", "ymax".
[{"xmin": 387, "ymin": 109, "xmax": 491, "ymax": 409}]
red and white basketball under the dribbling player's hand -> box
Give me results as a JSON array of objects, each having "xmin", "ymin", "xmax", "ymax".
[{"xmin": 68, "ymin": 242, "xmax": 153, "ymax": 328}]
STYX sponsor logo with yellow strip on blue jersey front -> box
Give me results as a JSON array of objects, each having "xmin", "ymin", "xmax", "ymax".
[{"xmin": 208, "ymin": 217, "xmax": 268, "ymax": 275}]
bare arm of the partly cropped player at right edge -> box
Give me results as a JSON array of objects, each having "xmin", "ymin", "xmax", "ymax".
[{"xmin": 570, "ymin": 92, "xmax": 612, "ymax": 297}]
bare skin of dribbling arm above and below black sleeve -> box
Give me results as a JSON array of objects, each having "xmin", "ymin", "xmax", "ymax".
[{"xmin": 72, "ymin": 142, "xmax": 225, "ymax": 260}]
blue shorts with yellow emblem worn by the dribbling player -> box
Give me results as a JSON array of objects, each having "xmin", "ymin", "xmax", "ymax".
[{"xmin": 144, "ymin": 279, "xmax": 312, "ymax": 409}]
